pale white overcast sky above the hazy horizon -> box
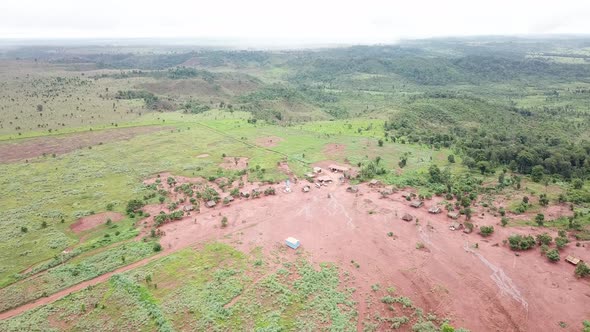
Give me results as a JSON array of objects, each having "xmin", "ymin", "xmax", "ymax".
[{"xmin": 0, "ymin": 0, "xmax": 590, "ymax": 43}]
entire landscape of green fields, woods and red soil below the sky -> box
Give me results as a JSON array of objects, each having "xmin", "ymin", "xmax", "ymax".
[{"xmin": 0, "ymin": 39, "xmax": 590, "ymax": 332}]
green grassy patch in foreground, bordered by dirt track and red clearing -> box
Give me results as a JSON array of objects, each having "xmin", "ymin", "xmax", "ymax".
[{"xmin": 0, "ymin": 244, "xmax": 356, "ymax": 331}]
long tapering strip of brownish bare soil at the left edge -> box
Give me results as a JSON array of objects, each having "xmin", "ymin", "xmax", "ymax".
[{"xmin": 0, "ymin": 126, "xmax": 164, "ymax": 163}]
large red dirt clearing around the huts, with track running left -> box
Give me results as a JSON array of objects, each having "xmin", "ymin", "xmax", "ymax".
[{"xmin": 0, "ymin": 169, "xmax": 590, "ymax": 331}]
